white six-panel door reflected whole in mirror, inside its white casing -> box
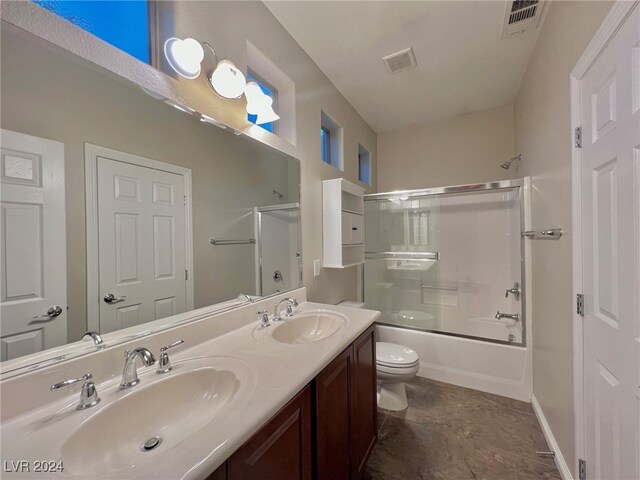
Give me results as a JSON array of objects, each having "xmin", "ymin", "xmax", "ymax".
[{"xmin": 97, "ymin": 157, "xmax": 187, "ymax": 333}]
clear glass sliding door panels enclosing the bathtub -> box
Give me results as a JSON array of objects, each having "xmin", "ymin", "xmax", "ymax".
[{"xmin": 364, "ymin": 188, "xmax": 524, "ymax": 344}]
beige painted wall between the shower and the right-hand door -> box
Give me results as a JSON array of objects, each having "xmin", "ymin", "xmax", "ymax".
[{"xmin": 515, "ymin": 2, "xmax": 612, "ymax": 472}]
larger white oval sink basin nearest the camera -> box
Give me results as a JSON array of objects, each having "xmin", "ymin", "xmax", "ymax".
[{"xmin": 3, "ymin": 357, "xmax": 256, "ymax": 478}]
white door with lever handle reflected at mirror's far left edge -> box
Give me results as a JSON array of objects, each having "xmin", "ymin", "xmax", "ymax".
[{"xmin": 0, "ymin": 130, "xmax": 67, "ymax": 361}]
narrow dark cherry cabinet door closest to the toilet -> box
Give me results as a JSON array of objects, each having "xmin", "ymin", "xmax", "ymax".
[{"xmin": 351, "ymin": 326, "xmax": 378, "ymax": 480}]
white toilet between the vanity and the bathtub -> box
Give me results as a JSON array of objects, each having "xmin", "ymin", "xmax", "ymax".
[{"xmin": 376, "ymin": 342, "xmax": 420, "ymax": 411}]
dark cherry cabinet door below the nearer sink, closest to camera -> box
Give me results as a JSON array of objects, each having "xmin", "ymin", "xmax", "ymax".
[{"xmin": 227, "ymin": 385, "xmax": 312, "ymax": 480}]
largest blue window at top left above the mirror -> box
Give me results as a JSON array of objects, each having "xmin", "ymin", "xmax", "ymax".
[{"xmin": 33, "ymin": 0, "xmax": 151, "ymax": 63}]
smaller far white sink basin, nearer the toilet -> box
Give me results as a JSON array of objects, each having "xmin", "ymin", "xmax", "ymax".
[{"xmin": 273, "ymin": 310, "xmax": 348, "ymax": 344}]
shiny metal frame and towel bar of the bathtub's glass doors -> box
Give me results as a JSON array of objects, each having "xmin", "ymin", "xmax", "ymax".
[{"xmin": 361, "ymin": 178, "xmax": 528, "ymax": 348}]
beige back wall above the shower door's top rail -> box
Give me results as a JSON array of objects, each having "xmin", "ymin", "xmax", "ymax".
[{"xmin": 378, "ymin": 105, "xmax": 523, "ymax": 192}]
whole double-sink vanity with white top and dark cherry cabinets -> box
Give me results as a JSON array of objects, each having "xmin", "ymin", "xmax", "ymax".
[{"xmin": 1, "ymin": 288, "xmax": 379, "ymax": 480}]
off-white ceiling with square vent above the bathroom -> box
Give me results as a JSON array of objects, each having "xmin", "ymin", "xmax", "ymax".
[{"xmin": 265, "ymin": 0, "xmax": 539, "ymax": 132}]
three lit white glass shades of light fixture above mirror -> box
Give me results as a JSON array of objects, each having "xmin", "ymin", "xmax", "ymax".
[{"xmin": 164, "ymin": 37, "xmax": 280, "ymax": 125}]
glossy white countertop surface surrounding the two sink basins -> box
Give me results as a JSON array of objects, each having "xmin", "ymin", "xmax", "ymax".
[{"xmin": 2, "ymin": 296, "xmax": 380, "ymax": 480}]
